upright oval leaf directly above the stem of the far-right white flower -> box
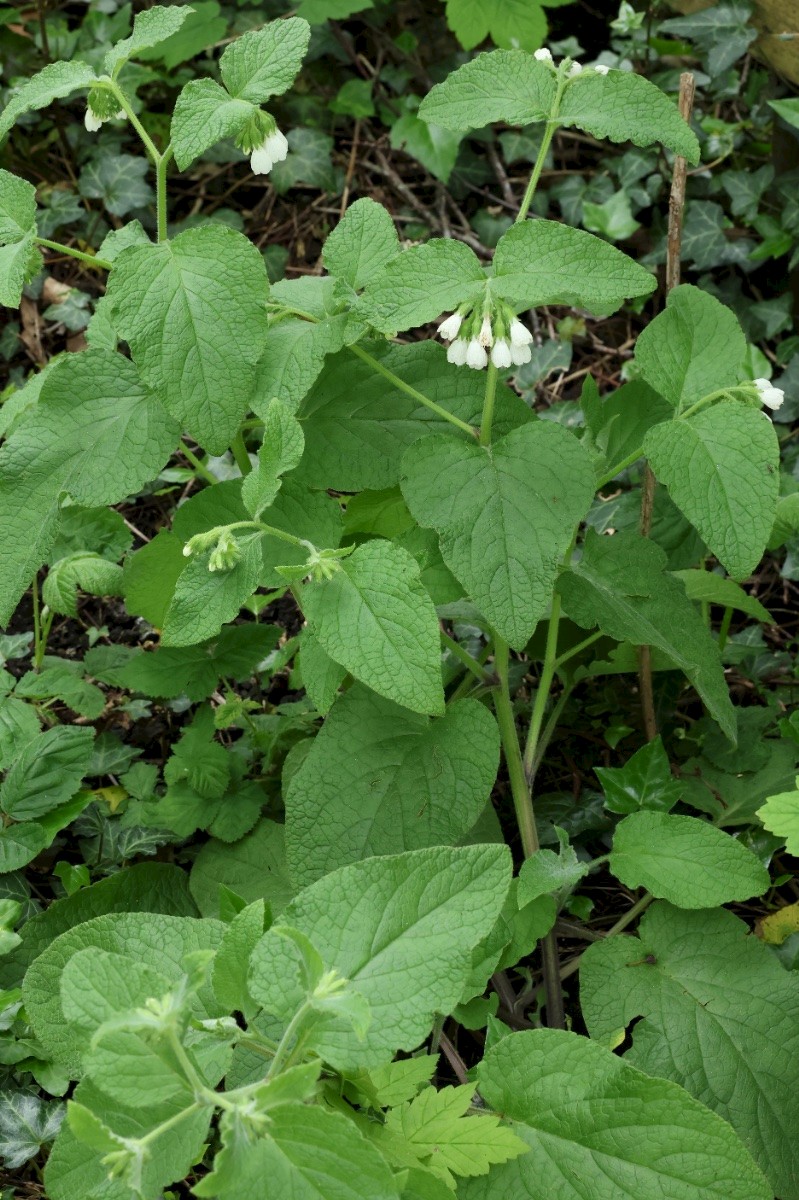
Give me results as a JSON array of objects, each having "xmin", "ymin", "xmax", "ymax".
[{"xmin": 636, "ymin": 283, "xmax": 746, "ymax": 413}]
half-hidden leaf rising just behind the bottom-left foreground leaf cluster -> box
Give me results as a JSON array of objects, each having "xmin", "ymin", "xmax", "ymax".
[{"xmin": 188, "ymin": 820, "xmax": 295, "ymax": 916}]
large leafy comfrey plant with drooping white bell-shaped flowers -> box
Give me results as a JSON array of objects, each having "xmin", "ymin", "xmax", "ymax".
[{"xmin": 0, "ymin": 14, "xmax": 799, "ymax": 1200}]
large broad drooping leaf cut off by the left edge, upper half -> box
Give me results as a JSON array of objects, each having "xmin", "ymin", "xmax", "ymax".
[{"xmin": 0, "ymin": 350, "xmax": 179, "ymax": 625}]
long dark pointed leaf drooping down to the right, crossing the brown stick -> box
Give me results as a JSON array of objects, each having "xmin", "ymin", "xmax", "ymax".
[{"xmin": 558, "ymin": 529, "xmax": 735, "ymax": 739}]
